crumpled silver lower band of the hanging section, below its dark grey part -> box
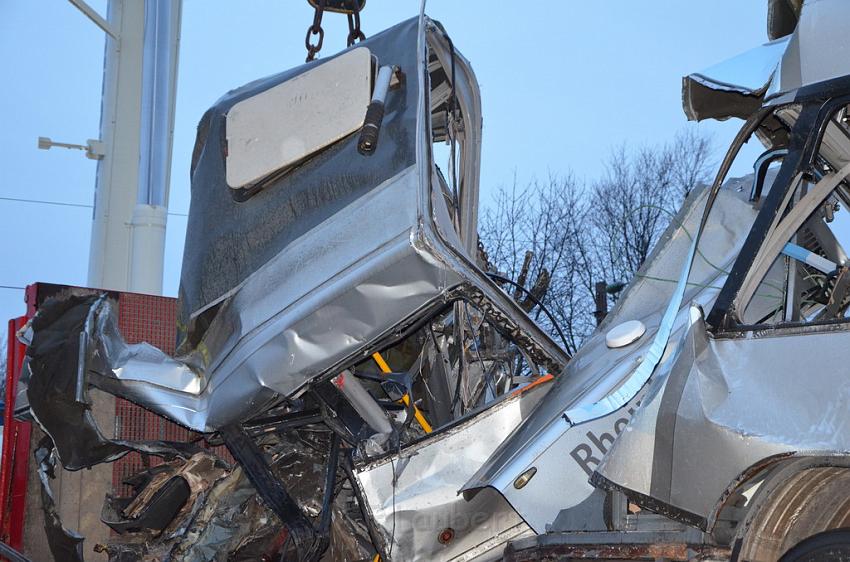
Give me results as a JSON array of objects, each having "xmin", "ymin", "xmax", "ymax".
[{"xmin": 88, "ymin": 164, "xmax": 459, "ymax": 431}]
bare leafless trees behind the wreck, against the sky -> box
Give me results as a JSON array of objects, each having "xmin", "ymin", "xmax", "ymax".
[{"xmin": 480, "ymin": 129, "xmax": 712, "ymax": 353}]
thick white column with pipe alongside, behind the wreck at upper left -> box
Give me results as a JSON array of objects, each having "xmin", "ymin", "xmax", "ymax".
[{"xmin": 88, "ymin": 0, "xmax": 182, "ymax": 294}]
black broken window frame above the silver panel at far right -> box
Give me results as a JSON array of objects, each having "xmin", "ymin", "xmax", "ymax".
[{"xmin": 707, "ymin": 77, "xmax": 850, "ymax": 337}]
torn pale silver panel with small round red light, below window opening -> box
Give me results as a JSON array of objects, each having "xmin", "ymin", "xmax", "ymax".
[{"xmin": 355, "ymin": 385, "xmax": 548, "ymax": 560}]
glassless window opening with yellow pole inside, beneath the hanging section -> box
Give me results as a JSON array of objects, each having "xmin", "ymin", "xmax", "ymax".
[{"xmin": 344, "ymin": 301, "xmax": 551, "ymax": 450}]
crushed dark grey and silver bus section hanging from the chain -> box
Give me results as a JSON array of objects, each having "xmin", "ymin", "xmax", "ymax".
[{"xmin": 21, "ymin": 16, "xmax": 568, "ymax": 436}]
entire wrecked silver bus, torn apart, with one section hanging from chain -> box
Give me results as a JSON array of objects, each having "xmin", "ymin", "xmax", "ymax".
[{"xmin": 9, "ymin": 0, "xmax": 850, "ymax": 561}]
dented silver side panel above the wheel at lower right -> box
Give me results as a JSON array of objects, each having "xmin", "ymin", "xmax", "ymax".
[{"xmin": 599, "ymin": 304, "xmax": 850, "ymax": 525}]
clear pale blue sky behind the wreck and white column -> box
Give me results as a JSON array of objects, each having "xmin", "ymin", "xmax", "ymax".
[{"xmin": 0, "ymin": 0, "xmax": 767, "ymax": 320}]
